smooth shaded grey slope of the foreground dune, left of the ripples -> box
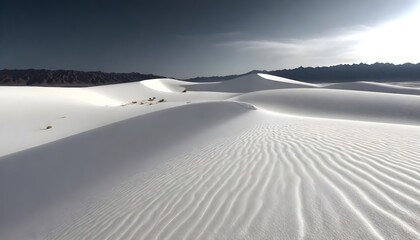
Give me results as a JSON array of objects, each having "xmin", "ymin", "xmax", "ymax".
[{"xmin": 0, "ymin": 102, "xmax": 251, "ymax": 239}]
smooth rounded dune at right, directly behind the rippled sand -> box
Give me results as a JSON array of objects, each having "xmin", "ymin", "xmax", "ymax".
[{"xmin": 233, "ymin": 89, "xmax": 420, "ymax": 125}]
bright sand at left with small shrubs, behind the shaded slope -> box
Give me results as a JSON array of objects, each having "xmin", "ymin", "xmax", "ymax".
[{"xmin": 0, "ymin": 81, "xmax": 233, "ymax": 156}]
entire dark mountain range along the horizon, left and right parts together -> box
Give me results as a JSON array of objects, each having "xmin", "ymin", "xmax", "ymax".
[{"xmin": 0, "ymin": 63, "xmax": 420, "ymax": 87}]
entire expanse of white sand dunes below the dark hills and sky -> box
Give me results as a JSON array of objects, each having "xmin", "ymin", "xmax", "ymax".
[{"xmin": 0, "ymin": 74, "xmax": 420, "ymax": 240}]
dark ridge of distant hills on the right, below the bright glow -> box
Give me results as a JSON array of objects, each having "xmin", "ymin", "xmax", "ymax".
[{"xmin": 188, "ymin": 63, "xmax": 420, "ymax": 83}]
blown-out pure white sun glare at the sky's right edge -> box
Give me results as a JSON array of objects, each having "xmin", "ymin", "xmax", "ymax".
[{"xmin": 355, "ymin": 6, "xmax": 420, "ymax": 63}]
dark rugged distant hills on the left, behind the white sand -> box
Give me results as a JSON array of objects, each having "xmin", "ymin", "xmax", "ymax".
[{"xmin": 0, "ymin": 69, "xmax": 160, "ymax": 87}]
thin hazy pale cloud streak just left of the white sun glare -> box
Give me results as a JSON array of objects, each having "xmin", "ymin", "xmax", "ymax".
[{"xmin": 216, "ymin": 30, "xmax": 357, "ymax": 67}]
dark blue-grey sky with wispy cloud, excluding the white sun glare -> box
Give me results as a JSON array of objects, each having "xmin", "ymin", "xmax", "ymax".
[{"xmin": 0, "ymin": 0, "xmax": 419, "ymax": 78}]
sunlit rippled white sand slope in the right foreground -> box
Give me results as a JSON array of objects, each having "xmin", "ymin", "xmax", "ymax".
[{"xmin": 41, "ymin": 112, "xmax": 420, "ymax": 239}]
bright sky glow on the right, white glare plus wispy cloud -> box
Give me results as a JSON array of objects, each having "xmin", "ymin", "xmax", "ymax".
[{"xmin": 225, "ymin": 4, "xmax": 420, "ymax": 69}]
